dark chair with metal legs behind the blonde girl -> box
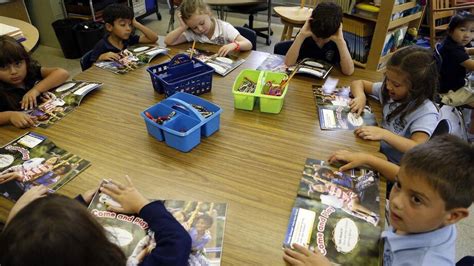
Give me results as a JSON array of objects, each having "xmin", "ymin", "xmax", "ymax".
[{"xmin": 225, "ymin": 0, "xmax": 273, "ymax": 45}]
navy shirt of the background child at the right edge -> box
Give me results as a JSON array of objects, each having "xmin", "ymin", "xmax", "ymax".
[{"xmin": 439, "ymin": 36, "xmax": 471, "ymax": 93}]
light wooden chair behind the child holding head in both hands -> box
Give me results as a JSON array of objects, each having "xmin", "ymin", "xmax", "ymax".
[{"xmin": 273, "ymin": 0, "xmax": 319, "ymax": 41}]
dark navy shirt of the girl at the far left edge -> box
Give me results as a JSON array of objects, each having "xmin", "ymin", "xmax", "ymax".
[{"xmin": 0, "ymin": 63, "xmax": 43, "ymax": 112}]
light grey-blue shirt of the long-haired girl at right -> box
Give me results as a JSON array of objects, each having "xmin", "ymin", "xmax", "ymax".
[{"xmin": 372, "ymin": 82, "xmax": 439, "ymax": 165}]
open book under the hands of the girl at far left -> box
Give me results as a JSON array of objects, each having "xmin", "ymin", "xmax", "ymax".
[{"xmin": 26, "ymin": 81, "xmax": 102, "ymax": 128}]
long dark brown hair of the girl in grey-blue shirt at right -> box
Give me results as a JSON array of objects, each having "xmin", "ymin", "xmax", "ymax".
[{"xmin": 382, "ymin": 45, "xmax": 439, "ymax": 123}]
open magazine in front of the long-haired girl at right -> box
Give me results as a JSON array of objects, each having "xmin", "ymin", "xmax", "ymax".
[{"xmin": 313, "ymin": 81, "xmax": 377, "ymax": 130}]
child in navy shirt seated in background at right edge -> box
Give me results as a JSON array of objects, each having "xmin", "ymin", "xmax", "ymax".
[{"xmin": 438, "ymin": 12, "xmax": 474, "ymax": 106}]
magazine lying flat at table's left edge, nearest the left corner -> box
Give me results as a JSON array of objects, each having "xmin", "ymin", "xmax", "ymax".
[{"xmin": 0, "ymin": 132, "xmax": 90, "ymax": 201}]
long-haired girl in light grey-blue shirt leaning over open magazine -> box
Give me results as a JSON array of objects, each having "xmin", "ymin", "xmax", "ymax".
[{"xmin": 349, "ymin": 46, "xmax": 438, "ymax": 164}]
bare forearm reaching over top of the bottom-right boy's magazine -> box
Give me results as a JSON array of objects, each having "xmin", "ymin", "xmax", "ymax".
[{"xmin": 328, "ymin": 150, "xmax": 400, "ymax": 181}]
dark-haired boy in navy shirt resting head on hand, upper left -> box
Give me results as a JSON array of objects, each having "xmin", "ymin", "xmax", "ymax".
[{"xmin": 88, "ymin": 4, "xmax": 158, "ymax": 65}]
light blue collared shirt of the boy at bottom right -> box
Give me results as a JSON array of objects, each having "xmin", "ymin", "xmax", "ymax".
[{"xmin": 382, "ymin": 225, "xmax": 456, "ymax": 266}]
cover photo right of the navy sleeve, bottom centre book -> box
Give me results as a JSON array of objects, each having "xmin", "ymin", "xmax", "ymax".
[{"xmin": 165, "ymin": 200, "xmax": 227, "ymax": 266}]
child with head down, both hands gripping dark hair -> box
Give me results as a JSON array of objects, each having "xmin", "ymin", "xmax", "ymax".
[{"xmin": 285, "ymin": 2, "xmax": 354, "ymax": 75}]
